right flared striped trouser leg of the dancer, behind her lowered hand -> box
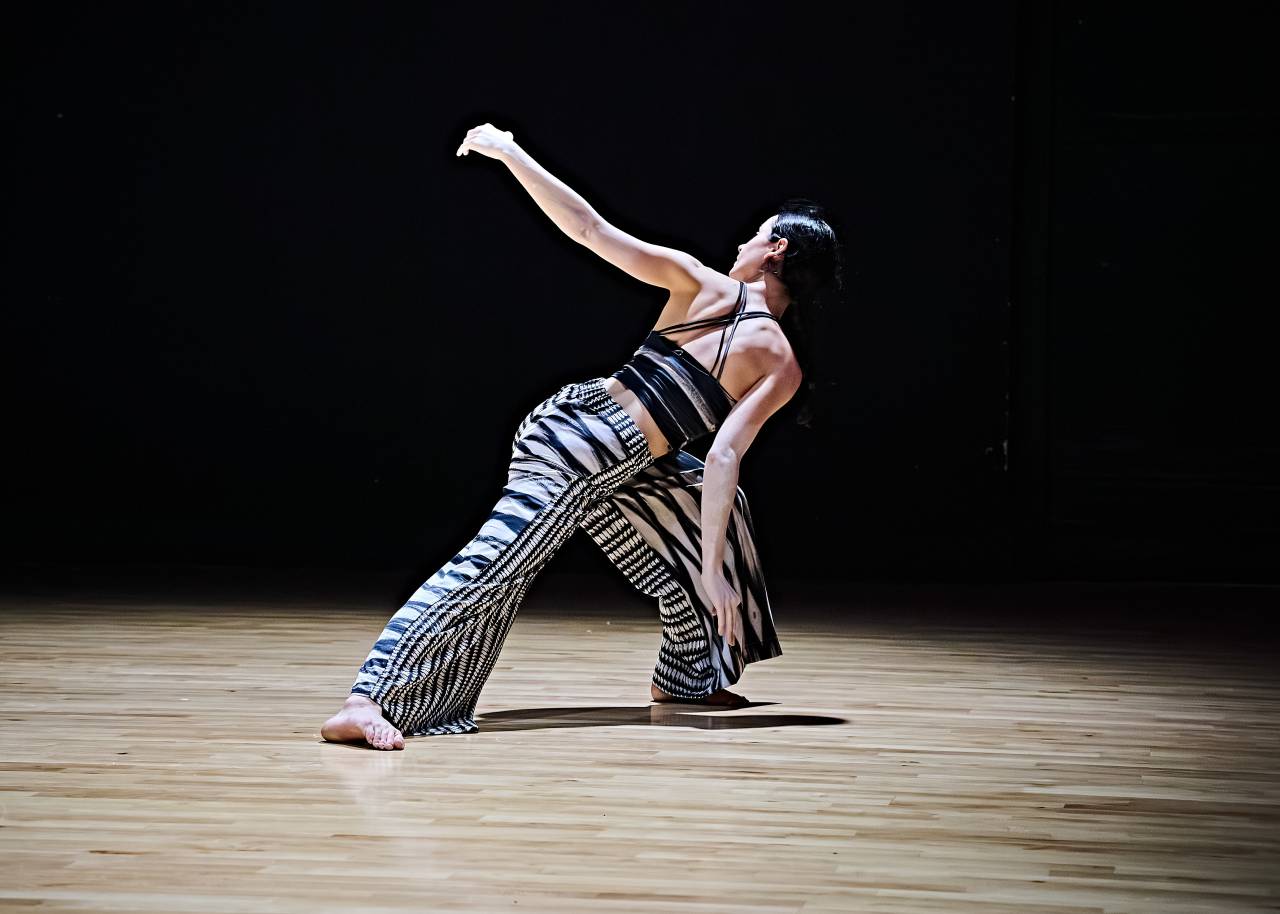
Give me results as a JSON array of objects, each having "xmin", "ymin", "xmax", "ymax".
[{"xmin": 582, "ymin": 451, "xmax": 782, "ymax": 698}]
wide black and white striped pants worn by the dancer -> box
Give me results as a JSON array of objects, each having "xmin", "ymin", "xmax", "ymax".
[{"xmin": 352, "ymin": 378, "xmax": 782, "ymax": 736}]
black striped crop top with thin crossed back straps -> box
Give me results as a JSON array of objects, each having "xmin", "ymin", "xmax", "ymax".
[{"xmin": 612, "ymin": 280, "xmax": 777, "ymax": 451}]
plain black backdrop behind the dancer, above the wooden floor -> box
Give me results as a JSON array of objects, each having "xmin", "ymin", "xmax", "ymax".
[{"xmin": 4, "ymin": 1, "xmax": 1280, "ymax": 579}]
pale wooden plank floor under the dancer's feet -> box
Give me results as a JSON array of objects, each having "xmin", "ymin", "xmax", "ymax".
[{"xmin": 0, "ymin": 573, "xmax": 1280, "ymax": 914}]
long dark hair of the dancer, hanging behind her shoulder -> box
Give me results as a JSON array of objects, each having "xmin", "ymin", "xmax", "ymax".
[{"xmin": 769, "ymin": 197, "xmax": 845, "ymax": 428}]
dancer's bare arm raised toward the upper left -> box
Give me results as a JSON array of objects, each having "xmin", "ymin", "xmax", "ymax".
[{"xmin": 457, "ymin": 124, "xmax": 709, "ymax": 291}]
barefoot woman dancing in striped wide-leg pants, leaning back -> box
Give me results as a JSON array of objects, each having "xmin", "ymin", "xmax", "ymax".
[{"xmin": 320, "ymin": 124, "xmax": 841, "ymax": 749}]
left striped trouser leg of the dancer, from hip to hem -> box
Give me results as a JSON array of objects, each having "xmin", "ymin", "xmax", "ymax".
[{"xmin": 352, "ymin": 379, "xmax": 653, "ymax": 736}]
